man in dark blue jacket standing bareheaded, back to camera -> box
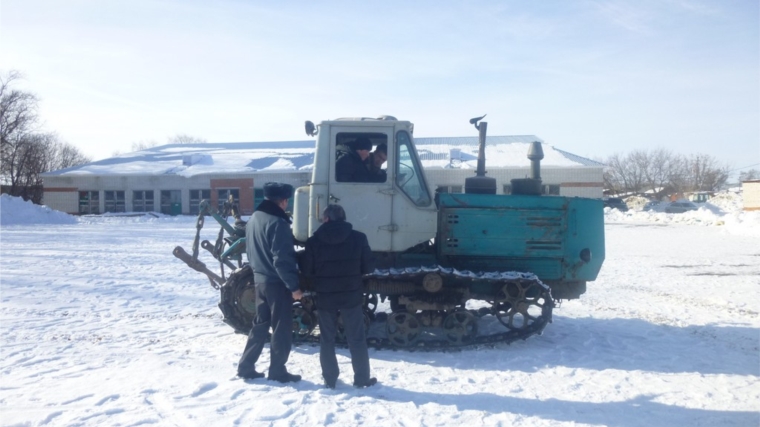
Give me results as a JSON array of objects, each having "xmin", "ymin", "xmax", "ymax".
[{"xmin": 301, "ymin": 205, "xmax": 377, "ymax": 388}]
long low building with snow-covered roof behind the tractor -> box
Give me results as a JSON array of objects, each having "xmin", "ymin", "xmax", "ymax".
[{"xmin": 43, "ymin": 135, "xmax": 604, "ymax": 215}]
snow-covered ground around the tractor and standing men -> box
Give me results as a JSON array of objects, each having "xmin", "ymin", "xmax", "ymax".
[{"xmin": 0, "ymin": 196, "xmax": 760, "ymax": 427}]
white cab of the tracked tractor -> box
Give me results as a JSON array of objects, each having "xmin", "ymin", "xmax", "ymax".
[{"xmin": 293, "ymin": 116, "xmax": 437, "ymax": 252}]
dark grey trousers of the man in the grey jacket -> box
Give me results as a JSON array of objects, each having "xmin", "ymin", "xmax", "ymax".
[{"xmin": 238, "ymin": 283, "xmax": 293, "ymax": 377}]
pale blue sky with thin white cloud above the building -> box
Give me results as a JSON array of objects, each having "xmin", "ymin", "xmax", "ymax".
[{"xmin": 0, "ymin": 0, "xmax": 760, "ymax": 176}]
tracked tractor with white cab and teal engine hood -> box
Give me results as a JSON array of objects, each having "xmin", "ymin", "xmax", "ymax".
[{"xmin": 175, "ymin": 116, "xmax": 605, "ymax": 349}]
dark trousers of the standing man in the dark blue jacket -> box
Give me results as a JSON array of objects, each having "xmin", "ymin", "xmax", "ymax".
[{"xmin": 317, "ymin": 305, "xmax": 369, "ymax": 384}]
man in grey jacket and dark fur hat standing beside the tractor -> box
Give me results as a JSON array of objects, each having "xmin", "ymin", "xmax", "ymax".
[{"xmin": 238, "ymin": 182, "xmax": 302, "ymax": 383}]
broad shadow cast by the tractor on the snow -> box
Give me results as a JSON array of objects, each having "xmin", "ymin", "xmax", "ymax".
[{"xmin": 364, "ymin": 316, "xmax": 760, "ymax": 376}]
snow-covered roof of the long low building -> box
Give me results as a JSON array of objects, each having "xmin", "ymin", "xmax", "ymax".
[{"xmin": 43, "ymin": 135, "xmax": 603, "ymax": 177}]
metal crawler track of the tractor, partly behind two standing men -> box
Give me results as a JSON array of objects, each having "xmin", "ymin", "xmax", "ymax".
[{"xmin": 219, "ymin": 266, "xmax": 554, "ymax": 351}]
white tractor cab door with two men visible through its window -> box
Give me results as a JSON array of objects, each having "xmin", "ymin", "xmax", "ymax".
[{"xmin": 328, "ymin": 126, "xmax": 395, "ymax": 251}]
